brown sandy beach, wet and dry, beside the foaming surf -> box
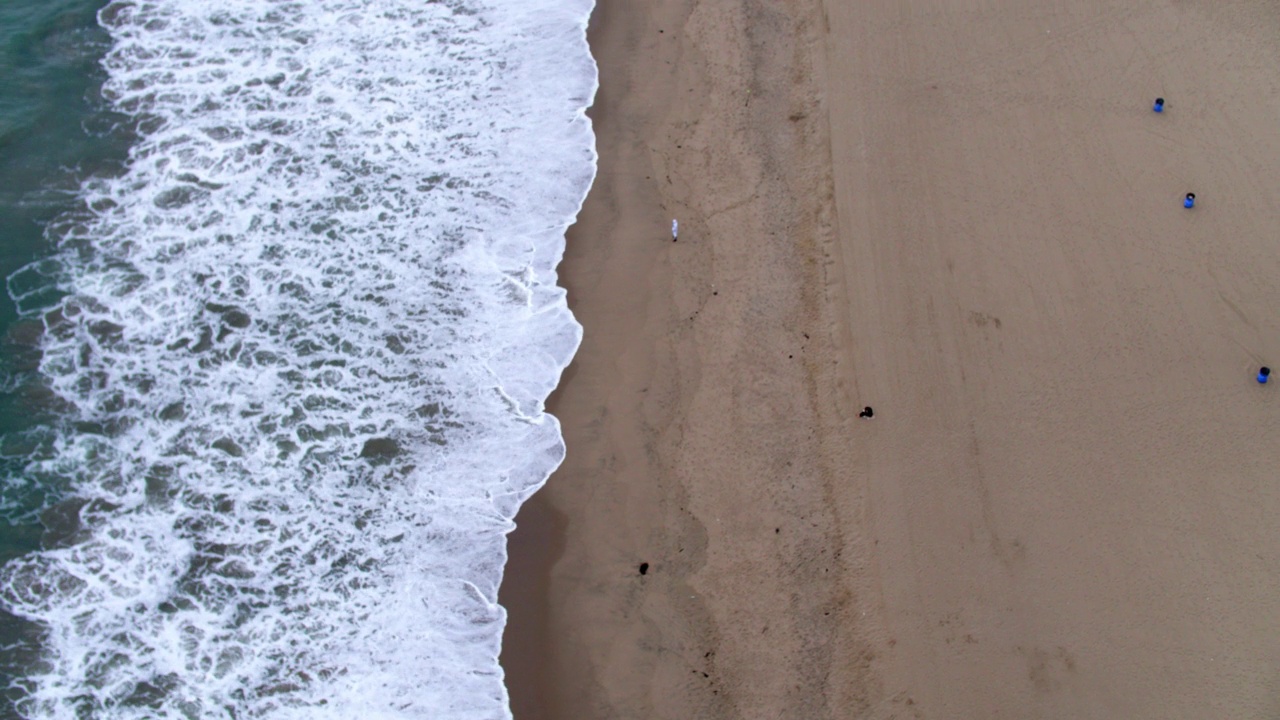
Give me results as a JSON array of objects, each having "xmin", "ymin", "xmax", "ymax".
[{"xmin": 504, "ymin": 0, "xmax": 1280, "ymax": 720}]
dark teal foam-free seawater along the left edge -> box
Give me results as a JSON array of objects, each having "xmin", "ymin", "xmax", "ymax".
[{"xmin": 0, "ymin": 0, "xmax": 120, "ymax": 717}]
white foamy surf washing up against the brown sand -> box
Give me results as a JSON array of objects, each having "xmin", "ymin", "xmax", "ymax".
[{"xmin": 0, "ymin": 0, "xmax": 596, "ymax": 719}]
